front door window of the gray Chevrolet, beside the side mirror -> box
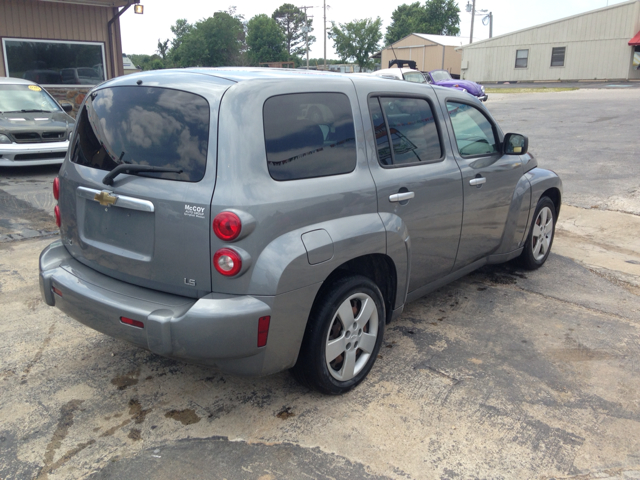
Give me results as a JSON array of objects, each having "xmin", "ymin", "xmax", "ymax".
[{"xmin": 447, "ymin": 102, "xmax": 498, "ymax": 157}]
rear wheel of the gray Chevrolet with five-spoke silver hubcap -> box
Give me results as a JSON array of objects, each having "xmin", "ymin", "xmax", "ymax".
[{"xmin": 292, "ymin": 275, "xmax": 386, "ymax": 395}]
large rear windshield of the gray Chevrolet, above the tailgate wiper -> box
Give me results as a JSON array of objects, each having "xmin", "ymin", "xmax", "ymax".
[{"xmin": 71, "ymin": 86, "xmax": 209, "ymax": 182}]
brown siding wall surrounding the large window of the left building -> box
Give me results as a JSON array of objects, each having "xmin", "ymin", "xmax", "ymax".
[{"xmin": 0, "ymin": 0, "xmax": 123, "ymax": 77}]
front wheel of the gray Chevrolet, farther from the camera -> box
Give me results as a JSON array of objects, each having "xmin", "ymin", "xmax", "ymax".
[{"xmin": 518, "ymin": 197, "xmax": 556, "ymax": 270}]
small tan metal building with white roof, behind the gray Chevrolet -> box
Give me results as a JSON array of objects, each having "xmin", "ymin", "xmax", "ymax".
[{"xmin": 380, "ymin": 33, "xmax": 469, "ymax": 75}]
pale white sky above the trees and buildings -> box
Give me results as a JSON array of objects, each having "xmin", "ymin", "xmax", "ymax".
[{"xmin": 120, "ymin": 0, "xmax": 626, "ymax": 59}]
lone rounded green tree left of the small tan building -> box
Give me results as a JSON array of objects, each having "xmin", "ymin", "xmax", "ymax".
[{"xmin": 330, "ymin": 17, "xmax": 382, "ymax": 69}]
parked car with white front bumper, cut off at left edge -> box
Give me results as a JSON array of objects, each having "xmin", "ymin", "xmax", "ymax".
[{"xmin": 0, "ymin": 77, "xmax": 76, "ymax": 167}]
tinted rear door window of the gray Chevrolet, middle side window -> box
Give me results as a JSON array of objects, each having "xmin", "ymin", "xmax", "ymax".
[{"xmin": 369, "ymin": 97, "xmax": 442, "ymax": 165}]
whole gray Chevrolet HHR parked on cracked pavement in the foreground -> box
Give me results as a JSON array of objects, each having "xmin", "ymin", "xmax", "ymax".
[{"xmin": 40, "ymin": 68, "xmax": 562, "ymax": 394}]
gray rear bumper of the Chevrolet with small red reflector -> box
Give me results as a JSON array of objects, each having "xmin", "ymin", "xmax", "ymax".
[{"xmin": 40, "ymin": 241, "xmax": 276, "ymax": 375}]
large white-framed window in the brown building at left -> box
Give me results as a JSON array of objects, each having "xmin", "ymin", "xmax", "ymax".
[{"xmin": 2, "ymin": 38, "xmax": 106, "ymax": 85}]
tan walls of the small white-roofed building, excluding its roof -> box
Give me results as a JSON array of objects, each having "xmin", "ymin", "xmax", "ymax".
[{"xmin": 380, "ymin": 35, "xmax": 462, "ymax": 74}]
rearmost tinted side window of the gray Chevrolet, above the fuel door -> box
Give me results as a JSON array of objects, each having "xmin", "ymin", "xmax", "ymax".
[{"xmin": 263, "ymin": 93, "xmax": 356, "ymax": 180}]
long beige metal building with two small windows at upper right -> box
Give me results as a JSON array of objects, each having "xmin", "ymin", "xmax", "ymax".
[{"xmin": 458, "ymin": 0, "xmax": 640, "ymax": 82}]
